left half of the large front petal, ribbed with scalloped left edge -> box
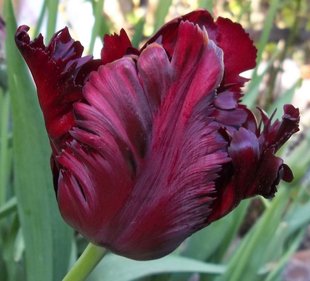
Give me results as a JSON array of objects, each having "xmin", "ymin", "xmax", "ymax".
[{"xmin": 58, "ymin": 51, "xmax": 160, "ymax": 248}]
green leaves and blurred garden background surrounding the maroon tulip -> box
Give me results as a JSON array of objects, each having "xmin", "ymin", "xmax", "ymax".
[{"xmin": 0, "ymin": 0, "xmax": 310, "ymax": 281}]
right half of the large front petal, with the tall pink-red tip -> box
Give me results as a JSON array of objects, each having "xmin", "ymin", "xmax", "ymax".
[{"xmin": 114, "ymin": 22, "xmax": 230, "ymax": 259}]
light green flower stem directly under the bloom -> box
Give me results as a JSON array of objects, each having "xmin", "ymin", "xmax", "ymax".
[{"xmin": 62, "ymin": 243, "xmax": 106, "ymax": 281}]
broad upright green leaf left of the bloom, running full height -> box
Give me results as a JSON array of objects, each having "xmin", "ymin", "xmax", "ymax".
[{"xmin": 5, "ymin": 0, "xmax": 72, "ymax": 281}]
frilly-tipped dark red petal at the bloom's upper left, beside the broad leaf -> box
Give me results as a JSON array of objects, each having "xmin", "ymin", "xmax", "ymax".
[{"xmin": 15, "ymin": 26, "xmax": 99, "ymax": 140}]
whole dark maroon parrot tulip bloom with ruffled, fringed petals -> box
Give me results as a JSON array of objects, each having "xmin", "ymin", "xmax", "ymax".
[{"xmin": 16, "ymin": 10, "xmax": 299, "ymax": 260}]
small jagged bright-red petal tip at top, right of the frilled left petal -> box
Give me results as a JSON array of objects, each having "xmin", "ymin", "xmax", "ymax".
[{"xmin": 101, "ymin": 29, "xmax": 139, "ymax": 64}]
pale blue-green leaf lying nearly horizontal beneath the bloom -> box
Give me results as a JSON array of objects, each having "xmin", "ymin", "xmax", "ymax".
[{"xmin": 87, "ymin": 254, "xmax": 225, "ymax": 281}]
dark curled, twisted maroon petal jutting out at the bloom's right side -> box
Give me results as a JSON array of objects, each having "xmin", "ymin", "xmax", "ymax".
[{"xmin": 209, "ymin": 105, "xmax": 299, "ymax": 221}]
